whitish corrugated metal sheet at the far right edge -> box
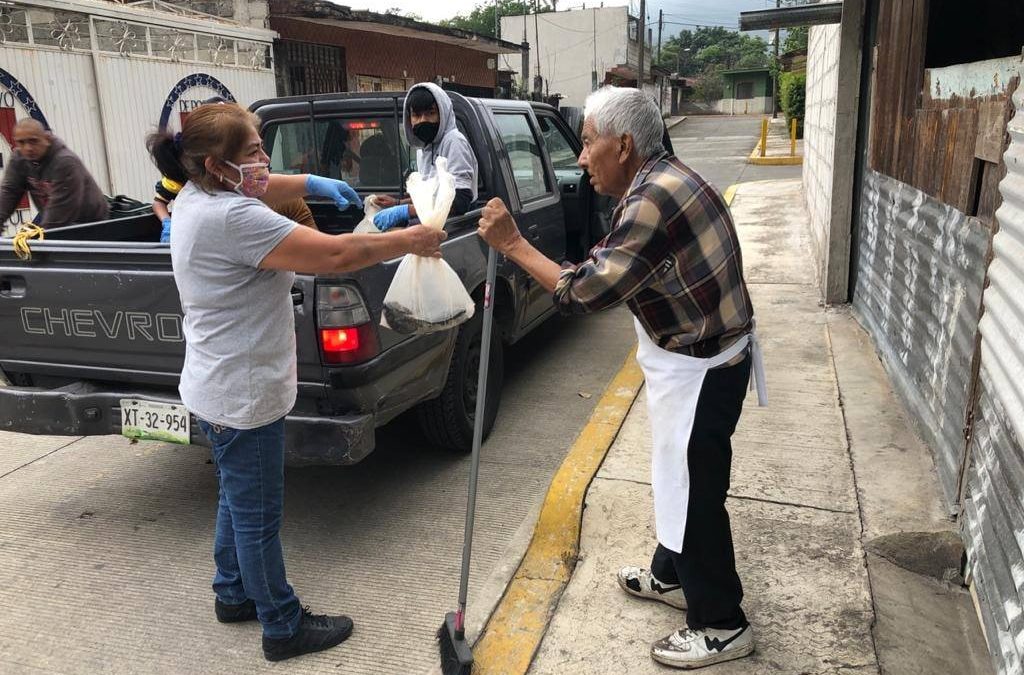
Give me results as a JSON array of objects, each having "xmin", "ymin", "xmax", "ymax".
[{"xmin": 964, "ymin": 76, "xmax": 1024, "ymax": 673}]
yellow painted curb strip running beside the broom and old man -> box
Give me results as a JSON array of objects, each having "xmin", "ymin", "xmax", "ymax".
[{"xmin": 473, "ymin": 348, "xmax": 643, "ymax": 675}]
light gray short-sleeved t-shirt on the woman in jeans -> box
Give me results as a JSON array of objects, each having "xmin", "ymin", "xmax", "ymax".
[{"xmin": 171, "ymin": 182, "xmax": 299, "ymax": 429}]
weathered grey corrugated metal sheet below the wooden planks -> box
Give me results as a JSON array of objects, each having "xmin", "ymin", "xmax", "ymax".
[{"xmin": 853, "ymin": 170, "xmax": 989, "ymax": 513}]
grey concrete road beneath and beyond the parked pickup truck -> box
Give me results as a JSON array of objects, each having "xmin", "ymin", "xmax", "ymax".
[{"xmin": 0, "ymin": 112, "xmax": 800, "ymax": 675}]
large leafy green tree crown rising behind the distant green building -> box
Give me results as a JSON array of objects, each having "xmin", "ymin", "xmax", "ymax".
[{"xmin": 658, "ymin": 26, "xmax": 768, "ymax": 77}]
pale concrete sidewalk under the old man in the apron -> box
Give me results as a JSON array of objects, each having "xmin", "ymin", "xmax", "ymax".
[{"xmin": 529, "ymin": 180, "xmax": 990, "ymax": 675}]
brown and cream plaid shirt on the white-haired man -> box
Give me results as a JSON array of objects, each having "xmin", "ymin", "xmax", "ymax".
[{"xmin": 554, "ymin": 153, "xmax": 754, "ymax": 358}]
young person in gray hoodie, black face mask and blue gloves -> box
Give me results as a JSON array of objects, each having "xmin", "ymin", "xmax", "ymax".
[{"xmin": 374, "ymin": 82, "xmax": 477, "ymax": 230}]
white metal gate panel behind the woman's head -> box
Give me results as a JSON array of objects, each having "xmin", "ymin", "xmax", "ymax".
[{"xmin": 96, "ymin": 55, "xmax": 276, "ymax": 201}]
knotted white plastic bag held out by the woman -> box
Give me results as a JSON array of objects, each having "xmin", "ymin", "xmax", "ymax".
[{"xmin": 381, "ymin": 157, "xmax": 476, "ymax": 335}]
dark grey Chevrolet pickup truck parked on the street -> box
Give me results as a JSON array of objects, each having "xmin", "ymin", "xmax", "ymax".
[{"xmin": 0, "ymin": 92, "xmax": 609, "ymax": 465}]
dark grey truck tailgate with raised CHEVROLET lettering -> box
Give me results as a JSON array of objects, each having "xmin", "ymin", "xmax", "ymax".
[{"xmin": 0, "ymin": 242, "xmax": 321, "ymax": 386}]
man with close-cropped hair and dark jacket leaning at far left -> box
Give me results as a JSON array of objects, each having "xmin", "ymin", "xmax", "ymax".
[{"xmin": 0, "ymin": 118, "xmax": 110, "ymax": 228}]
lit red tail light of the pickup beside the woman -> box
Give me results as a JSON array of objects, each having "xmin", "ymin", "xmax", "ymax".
[{"xmin": 316, "ymin": 284, "xmax": 380, "ymax": 366}]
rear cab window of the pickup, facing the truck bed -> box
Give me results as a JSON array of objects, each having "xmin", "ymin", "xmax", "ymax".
[{"xmin": 264, "ymin": 117, "xmax": 401, "ymax": 192}]
